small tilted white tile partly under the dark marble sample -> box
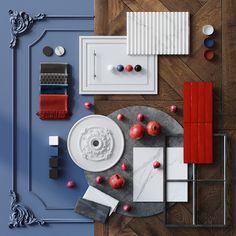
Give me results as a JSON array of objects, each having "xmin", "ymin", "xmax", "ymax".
[{"xmin": 83, "ymin": 186, "xmax": 119, "ymax": 215}]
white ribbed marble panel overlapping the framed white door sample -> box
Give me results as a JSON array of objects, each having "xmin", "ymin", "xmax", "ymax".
[{"xmin": 127, "ymin": 12, "xmax": 190, "ymax": 55}]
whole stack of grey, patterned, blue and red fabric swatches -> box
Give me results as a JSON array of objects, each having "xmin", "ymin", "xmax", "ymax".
[{"xmin": 37, "ymin": 63, "xmax": 70, "ymax": 120}]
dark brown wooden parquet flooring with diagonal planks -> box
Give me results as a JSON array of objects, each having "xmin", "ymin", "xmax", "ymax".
[{"xmin": 95, "ymin": 0, "xmax": 236, "ymax": 236}]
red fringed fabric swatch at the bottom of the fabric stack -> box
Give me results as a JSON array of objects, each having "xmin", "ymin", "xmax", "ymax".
[{"xmin": 37, "ymin": 94, "xmax": 70, "ymax": 120}]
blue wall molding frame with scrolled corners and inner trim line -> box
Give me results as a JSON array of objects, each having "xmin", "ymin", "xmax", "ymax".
[{"xmin": 9, "ymin": 10, "xmax": 94, "ymax": 228}]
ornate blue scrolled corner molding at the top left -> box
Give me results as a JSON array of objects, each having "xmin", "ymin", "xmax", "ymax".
[{"xmin": 8, "ymin": 10, "xmax": 46, "ymax": 48}]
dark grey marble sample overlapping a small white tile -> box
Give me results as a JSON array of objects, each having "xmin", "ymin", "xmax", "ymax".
[{"xmin": 75, "ymin": 198, "xmax": 111, "ymax": 223}]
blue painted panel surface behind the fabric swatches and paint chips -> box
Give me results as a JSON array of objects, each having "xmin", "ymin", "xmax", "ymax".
[{"xmin": 0, "ymin": 0, "xmax": 94, "ymax": 236}]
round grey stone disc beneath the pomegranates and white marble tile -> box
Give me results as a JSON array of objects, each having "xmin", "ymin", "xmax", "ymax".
[{"xmin": 85, "ymin": 106, "xmax": 183, "ymax": 217}]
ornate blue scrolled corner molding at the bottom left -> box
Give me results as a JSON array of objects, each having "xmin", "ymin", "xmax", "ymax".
[{"xmin": 9, "ymin": 190, "xmax": 45, "ymax": 228}]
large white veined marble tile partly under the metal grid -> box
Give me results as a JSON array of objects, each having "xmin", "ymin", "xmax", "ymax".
[{"xmin": 133, "ymin": 147, "xmax": 188, "ymax": 202}]
